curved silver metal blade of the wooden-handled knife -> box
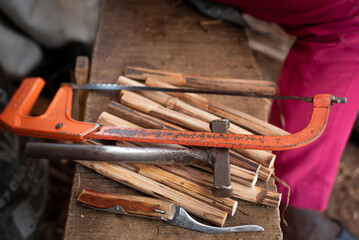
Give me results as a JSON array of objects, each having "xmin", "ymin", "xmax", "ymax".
[{"xmin": 166, "ymin": 206, "xmax": 264, "ymax": 233}]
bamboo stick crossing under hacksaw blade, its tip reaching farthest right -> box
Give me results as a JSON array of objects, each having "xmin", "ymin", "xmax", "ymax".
[{"xmin": 146, "ymin": 77, "xmax": 290, "ymax": 136}]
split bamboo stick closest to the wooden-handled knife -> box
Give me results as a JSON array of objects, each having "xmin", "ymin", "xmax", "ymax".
[{"xmin": 78, "ymin": 161, "xmax": 227, "ymax": 226}]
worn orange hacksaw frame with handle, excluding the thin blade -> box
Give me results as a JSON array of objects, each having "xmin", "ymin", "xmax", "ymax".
[{"xmin": 0, "ymin": 78, "xmax": 345, "ymax": 151}]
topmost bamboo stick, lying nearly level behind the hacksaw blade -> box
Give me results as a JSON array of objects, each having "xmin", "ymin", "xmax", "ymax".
[{"xmin": 126, "ymin": 67, "xmax": 275, "ymax": 94}]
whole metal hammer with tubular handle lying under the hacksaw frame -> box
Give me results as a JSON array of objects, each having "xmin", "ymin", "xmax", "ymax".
[{"xmin": 25, "ymin": 119, "xmax": 232, "ymax": 197}]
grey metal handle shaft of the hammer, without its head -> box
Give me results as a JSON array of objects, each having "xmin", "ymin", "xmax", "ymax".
[{"xmin": 25, "ymin": 142, "xmax": 211, "ymax": 165}]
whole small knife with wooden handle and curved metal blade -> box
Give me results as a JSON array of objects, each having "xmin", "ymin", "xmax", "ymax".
[{"xmin": 77, "ymin": 189, "xmax": 264, "ymax": 233}]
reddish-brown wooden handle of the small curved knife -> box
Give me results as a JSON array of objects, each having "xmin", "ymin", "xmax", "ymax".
[{"xmin": 77, "ymin": 189, "xmax": 175, "ymax": 219}]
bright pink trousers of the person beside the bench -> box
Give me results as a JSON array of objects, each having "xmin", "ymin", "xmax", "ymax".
[{"xmin": 219, "ymin": 0, "xmax": 359, "ymax": 211}]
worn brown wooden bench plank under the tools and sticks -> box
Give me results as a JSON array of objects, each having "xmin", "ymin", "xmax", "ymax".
[{"xmin": 64, "ymin": 0, "xmax": 282, "ymax": 240}]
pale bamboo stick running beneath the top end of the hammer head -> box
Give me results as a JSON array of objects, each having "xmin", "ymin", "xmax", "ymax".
[{"xmin": 120, "ymin": 88, "xmax": 275, "ymax": 167}]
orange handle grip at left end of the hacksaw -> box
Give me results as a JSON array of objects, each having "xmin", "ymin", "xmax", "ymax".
[{"xmin": 0, "ymin": 78, "xmax": 99, "ymax": 142}]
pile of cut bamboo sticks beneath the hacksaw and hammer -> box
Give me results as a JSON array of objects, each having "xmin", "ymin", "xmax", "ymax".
[{"xmin": 79, "ymin": 67, "xmax": 288, "ymax": 226}]
